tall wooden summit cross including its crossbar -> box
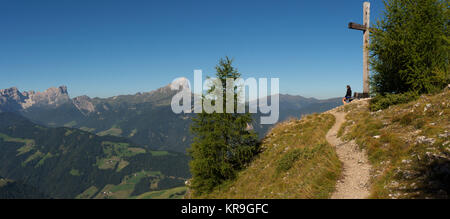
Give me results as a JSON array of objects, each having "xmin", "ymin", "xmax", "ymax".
[{"xmin": 348, "ymin": 2, "xmax": 370, "ymax": 98}]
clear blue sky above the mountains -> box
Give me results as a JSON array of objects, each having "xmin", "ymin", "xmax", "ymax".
[{"xmin": 0, "ymin": 0, "xmax": 383, "ymax": 98}]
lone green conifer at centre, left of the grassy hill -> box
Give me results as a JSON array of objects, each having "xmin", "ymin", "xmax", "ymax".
[{"xmin": 188, "ymin": 57, "xmax": 258, "ymax": 195}]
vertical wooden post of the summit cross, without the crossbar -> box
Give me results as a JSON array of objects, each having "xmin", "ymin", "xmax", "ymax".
[{"xmin": 363, "ymin": 2, "xmax": 370, "ymax": 96}]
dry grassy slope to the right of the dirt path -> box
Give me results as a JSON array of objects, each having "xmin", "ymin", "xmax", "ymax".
[{"xmin": 340, "ymin": 89, "xmax": 450, "ymax": 198}]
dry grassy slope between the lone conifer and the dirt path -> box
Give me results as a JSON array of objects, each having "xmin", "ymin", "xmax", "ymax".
[{"xmin": 196, "ymin": 114, "xmax": 341, "ymax": 199}]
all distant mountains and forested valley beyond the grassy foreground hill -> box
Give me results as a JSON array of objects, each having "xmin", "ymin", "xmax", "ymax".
[{"xmin": 0, "ymin": 82, "xmax": 340, "ymax": 198}]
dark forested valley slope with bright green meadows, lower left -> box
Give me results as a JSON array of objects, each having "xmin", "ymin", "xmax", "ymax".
[{"xmin": 0, "ymin": 113, "xmax": 189, "ymax": 198}]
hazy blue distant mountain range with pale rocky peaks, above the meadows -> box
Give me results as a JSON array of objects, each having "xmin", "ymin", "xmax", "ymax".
[{"xmin": 0, "ymin": 84, "xmax": 341, "ymax": 153}]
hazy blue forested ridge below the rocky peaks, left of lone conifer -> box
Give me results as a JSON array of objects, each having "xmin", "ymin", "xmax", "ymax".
[{"xmin": 22, "ymin": 102, "xmax": 190, "ymax": 153}]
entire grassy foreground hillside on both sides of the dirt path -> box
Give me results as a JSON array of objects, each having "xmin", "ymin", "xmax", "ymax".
[{"xmin": 198, "ymin": 87, "xmax": 450, "ymax": 199}]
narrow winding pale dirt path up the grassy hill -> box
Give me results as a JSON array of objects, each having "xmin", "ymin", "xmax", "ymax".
[{"xmin": 326, "ymin": 111, "xmax": 371, "ymax": 199}]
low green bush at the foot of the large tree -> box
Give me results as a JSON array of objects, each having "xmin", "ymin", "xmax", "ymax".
[{"xmin": 370, "ymin": 92, "xmax": 419, "ymax": 111}]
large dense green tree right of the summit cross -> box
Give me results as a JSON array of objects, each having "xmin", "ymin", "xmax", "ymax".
[{"xmin": 370, "ymin": 0, "xmax": 450, "ymax": 94}]
